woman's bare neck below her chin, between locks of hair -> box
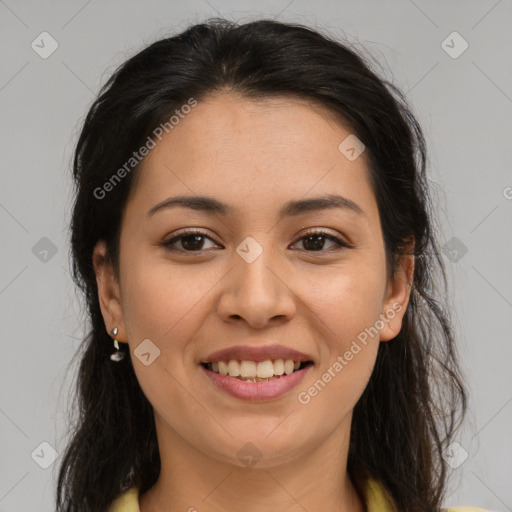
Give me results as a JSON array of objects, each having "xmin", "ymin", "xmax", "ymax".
[{"xmin": 139, "ymin": 412, "xmax": 366, "ymax": 512}]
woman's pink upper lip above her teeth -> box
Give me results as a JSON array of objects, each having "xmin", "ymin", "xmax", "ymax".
[{"xmin": 200, "ymin": 345, "xmax": 313, "ymax": 363}]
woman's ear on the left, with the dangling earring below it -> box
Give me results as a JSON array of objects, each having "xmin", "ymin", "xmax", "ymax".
[{"xmin": 92, "ymin": 240, "xmax": 126, "ymax": 343}]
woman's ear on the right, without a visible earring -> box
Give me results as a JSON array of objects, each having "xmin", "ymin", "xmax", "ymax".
[{"xmin": 380, "ymin": 241, "xmax": 414, "ymax": 341}]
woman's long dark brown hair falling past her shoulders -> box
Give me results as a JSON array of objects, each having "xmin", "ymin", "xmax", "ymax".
[{"xmin": 57, "ymin": 18, "xmax": 467, "ymax": 512}]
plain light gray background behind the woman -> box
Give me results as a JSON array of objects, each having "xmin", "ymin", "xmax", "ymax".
[{"xmin": 0, "ymin": 0, "xmax": 512, "ymax": 512}]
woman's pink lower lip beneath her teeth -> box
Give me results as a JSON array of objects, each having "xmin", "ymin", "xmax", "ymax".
[{"xmin": 199, "ymin": 364, "xmax": 313, "ymax": 402}]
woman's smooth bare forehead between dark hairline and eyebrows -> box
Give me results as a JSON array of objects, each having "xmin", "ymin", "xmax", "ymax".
[{"xmin": 129, "ymin": 94, "xmax": 373, "ymax": 224}]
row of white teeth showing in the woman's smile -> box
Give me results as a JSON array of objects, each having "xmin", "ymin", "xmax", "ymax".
[{"xmin": 209, "ymin": 359, "xmax": 306, "ymax": 380}]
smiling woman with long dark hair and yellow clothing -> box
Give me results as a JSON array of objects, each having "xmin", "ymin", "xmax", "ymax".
[{"xmin": 57, "ymin": 19, "xmax": 488, "ymax": 512}]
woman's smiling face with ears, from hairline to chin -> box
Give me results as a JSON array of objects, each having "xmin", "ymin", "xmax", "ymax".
[{"xmin": 95, "ymin": 94, "xmax": 412, "ymax": 467}]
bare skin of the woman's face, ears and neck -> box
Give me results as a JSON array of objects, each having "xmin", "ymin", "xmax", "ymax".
[{"xmin": 93, "ymin": 92, "xmax": 414, "ymax": 512}]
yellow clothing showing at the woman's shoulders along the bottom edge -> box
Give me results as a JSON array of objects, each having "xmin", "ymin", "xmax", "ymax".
[{"xmin": 108, "ymin": 480, "xmax": 487, "ymax": 512}]
